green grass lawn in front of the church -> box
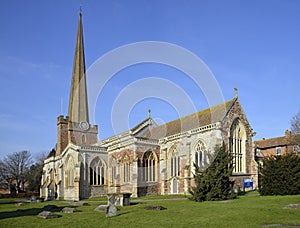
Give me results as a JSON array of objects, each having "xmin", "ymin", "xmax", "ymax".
[{"xmin": 0, "ymin": 195, "xmax": 300, "ymax": 228}]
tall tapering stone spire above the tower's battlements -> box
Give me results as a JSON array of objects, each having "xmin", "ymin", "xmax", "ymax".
[{"xmin": 68, "ymin": 11, "xmax": 89, "ymax": 123}]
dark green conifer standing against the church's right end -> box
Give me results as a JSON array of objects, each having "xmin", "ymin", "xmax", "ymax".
[{"xmin": 190, "ymin": 146, "xmax": 237, "ymax": 202}]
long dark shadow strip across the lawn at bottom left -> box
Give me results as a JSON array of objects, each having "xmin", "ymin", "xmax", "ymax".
[{"xmin": 0, "ymin": 205, "xmax": 73, "ymax": 220}]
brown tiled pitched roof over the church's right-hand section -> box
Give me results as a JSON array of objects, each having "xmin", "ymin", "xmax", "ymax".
[{"xmin": 149, "ymin": 98, "xmax": 236, "ymax": 139}]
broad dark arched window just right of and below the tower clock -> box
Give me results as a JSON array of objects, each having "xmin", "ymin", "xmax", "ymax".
[{"xmin": 90, "ymin": 158, "xmax": 106, "ymax": 185}]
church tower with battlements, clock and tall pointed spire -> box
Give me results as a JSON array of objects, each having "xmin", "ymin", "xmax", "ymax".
[{"xmin": 56, "ymin": 12, "xmax": 98, "ymax": 155}]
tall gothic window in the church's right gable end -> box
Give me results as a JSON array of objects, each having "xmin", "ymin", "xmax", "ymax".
[{"xmin": 229, "ymin": 120, "xmax": 246, "ymax": 173}]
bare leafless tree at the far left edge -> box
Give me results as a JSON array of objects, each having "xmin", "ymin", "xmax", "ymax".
[{"xmin": 0, "ymin": 150, "xmax": 31, "ymax": 192}]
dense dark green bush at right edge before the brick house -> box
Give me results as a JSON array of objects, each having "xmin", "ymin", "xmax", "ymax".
[{"xmin": 260, "ymin": 153, "xmax": 300, "ymax": 195}]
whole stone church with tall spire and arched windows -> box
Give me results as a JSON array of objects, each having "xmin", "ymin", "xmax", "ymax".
[{"xmin": 40, "ymin": 13, "xmax": 257, "ymax": 200}]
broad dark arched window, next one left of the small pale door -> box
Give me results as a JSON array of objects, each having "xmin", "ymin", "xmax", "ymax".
[{"xmin": 143, "ymin": 151, "xmax": 157, "ymax": 181}]
